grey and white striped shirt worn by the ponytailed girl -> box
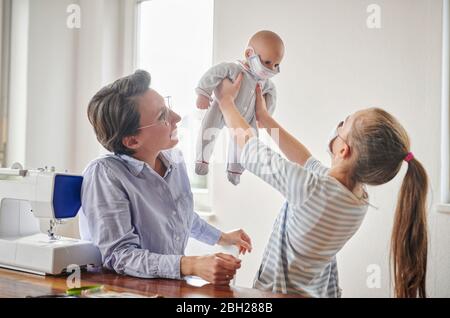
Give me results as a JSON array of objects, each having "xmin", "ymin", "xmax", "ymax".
[{"xmin": 241, "ymin": 137, "xmax": 368, "ymax": 297}]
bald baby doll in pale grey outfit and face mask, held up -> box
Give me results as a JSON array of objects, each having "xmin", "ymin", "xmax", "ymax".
[{"xmin": 195, "ymin": 31, "xmax": 284, "ymax": 185}]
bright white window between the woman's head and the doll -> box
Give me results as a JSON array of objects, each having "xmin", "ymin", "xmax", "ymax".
[{"xmin": 137, "ymin": 0, "xmax": 214, "ymax": 191}]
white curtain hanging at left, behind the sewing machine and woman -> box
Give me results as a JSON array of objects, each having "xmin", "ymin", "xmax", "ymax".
[{"xmin": 0, "ymin": 0, "xmax": 137, "ymax": 236}]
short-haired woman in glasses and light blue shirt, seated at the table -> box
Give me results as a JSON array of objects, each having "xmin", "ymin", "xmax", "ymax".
[{"xmin": 80, "ymin": 71, "xmax": 252, "ymax": 285}]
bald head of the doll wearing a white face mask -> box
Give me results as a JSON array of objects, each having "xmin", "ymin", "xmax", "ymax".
[{"xmin": 245, "ymin": 30, "xmax": 284, "ymax": 79}]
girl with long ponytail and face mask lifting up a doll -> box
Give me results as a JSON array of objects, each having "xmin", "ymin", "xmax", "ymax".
[{"xmin": 218, "ymin": 75, "xmax": 428, "ymax": 297}]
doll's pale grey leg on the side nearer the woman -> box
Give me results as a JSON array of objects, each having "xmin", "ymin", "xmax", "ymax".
[{"xmin": 195, "ymin": 101, "xmax": 225, "ymax": 175}]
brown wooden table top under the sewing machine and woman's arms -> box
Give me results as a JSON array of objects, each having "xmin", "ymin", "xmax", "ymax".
[{"xmin": 0, "ymin": 268, "xmax": 302, "ymax": 298}]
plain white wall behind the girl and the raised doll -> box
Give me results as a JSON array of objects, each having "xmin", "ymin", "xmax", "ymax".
[{"xmin": 200, "ymin": 0, "xmax": 450, "ymax": 297}]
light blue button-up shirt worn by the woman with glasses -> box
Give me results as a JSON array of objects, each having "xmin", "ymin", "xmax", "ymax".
[{"xmin": 79, "ymin": 149, "xmax": 221, "ymax": 279}]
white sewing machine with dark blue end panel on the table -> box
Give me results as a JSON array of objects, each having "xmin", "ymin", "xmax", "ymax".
[{"xmin": 0, "ymin": 164, "xmax": 101, "ymax": 275}]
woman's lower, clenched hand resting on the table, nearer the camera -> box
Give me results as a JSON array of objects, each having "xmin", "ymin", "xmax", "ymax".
[{"xmin": 180, "ymin": 253, "xmax": 241, "ymax": 285}]
